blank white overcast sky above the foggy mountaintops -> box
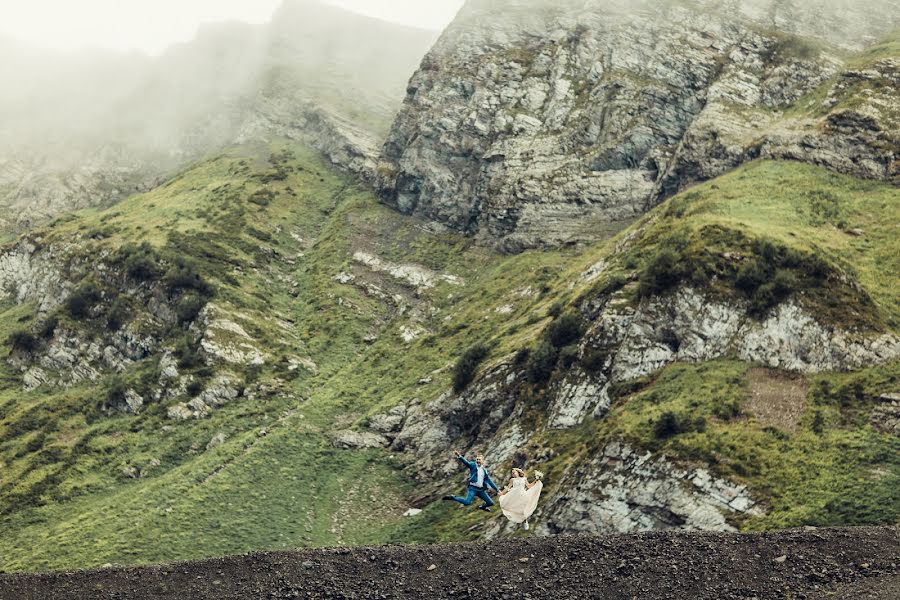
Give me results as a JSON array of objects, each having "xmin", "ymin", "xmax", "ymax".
[{"xmin": 0, "ymin": 0, "xmax": 463, "ymax": 55}]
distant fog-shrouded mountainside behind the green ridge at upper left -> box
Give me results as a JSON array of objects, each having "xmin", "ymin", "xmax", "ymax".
[{"xmin": 0, "ymin": 0, "xmax": 436, "ymax": 239}]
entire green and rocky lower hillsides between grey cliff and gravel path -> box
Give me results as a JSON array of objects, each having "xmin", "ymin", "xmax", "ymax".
[{"xmin": 0, "ymin": 135, "xmax": 900, "ymax": 570}]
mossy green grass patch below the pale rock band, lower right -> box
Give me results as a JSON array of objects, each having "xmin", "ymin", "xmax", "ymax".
[{"xmin": 603, "ymin": 361, "xmax": 900, "ymax": 530}]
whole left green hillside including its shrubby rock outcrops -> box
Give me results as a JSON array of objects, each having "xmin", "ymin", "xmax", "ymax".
[{"xmin": 0, "ymin": 138, "xmax": 562, "ymax": 568}]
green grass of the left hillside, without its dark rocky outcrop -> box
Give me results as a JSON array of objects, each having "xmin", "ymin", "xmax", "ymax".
[{"xmin": 0, "ymin": 144, "xmax": 564, "ymax": 569}]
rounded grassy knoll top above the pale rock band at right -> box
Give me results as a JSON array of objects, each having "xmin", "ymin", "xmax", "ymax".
[{"xmin": 613, "ymin": 162, "xmax": 900, "ymax": 331}]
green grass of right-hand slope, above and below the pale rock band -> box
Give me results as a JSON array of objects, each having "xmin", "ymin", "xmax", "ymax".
[{"xmin": 386, "ymin": 162, "xmax": 900, "ymax": 541}]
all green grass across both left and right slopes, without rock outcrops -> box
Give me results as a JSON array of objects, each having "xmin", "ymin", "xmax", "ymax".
[{"xmin": 0, "ymin": 142, "xmax": 900, "ymax": 570}]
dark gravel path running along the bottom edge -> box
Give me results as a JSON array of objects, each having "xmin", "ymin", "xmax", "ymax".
[{"xmin": 0, "ymin": 527, "xmax": 900, "ymax": 600}]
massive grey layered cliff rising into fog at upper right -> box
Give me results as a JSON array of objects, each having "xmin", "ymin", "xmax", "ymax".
[{"xmin": 377, "ymin": 0, "xmax": 900, "ymax": 250}]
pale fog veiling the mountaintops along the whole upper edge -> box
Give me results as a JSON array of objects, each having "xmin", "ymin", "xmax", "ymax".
[{"xmin": 0, "ymin": 0, "xmax": 900, "ymax": 237}]
